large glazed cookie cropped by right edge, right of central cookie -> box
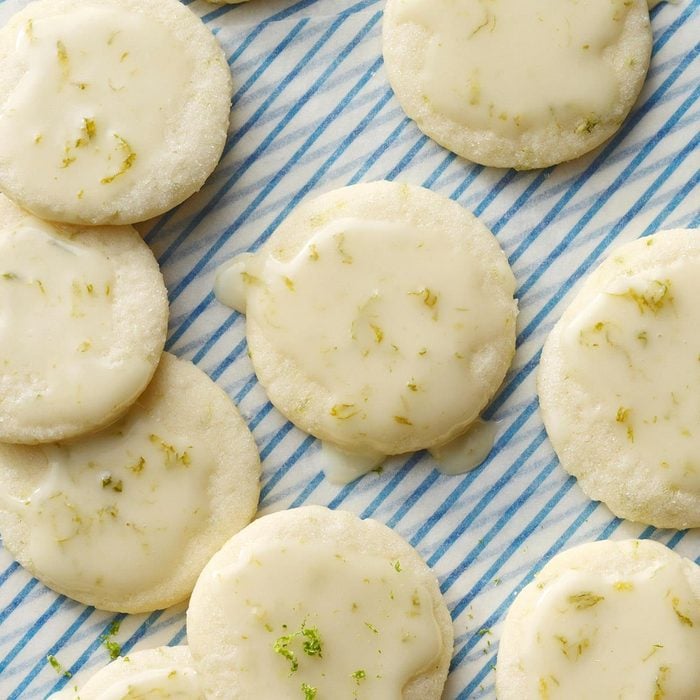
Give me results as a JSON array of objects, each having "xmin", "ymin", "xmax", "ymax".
[{"xmin": 537, "ymin": 230, "xmax": 700, "ymax": 529}]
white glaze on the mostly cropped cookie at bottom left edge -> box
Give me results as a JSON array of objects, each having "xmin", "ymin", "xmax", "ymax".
[{"xmin": 98, "ymin": 667, "xmax": 204, "ymax": 700}]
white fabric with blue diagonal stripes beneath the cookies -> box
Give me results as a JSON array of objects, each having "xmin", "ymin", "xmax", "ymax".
[{"xmin": 0, "ymin": 0, "xmax": 700, "ymax": 700}]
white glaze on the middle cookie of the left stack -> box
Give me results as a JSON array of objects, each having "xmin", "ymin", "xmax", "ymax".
[{"xmin": 0, "ymin": 218, "xmax": 152, "ymax": 429}]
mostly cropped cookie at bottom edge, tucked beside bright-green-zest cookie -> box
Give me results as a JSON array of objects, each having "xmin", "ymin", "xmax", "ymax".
[{"xmin": 49, "ymin": 646, "xmax": 204, "ymax": 700}]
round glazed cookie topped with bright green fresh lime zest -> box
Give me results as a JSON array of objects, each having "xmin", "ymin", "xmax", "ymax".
[{"xmin": 187, "ymin": 506, "xmax": 453, "ymax": 700}]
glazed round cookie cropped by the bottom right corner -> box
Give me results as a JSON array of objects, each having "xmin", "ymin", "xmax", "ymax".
[{"xmin": 496, "ymin": 540, "xmax": 700, "ymax": 700}]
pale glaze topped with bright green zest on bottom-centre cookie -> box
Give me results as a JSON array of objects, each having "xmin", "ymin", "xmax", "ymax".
[{"xmin": 205, "ymin": 542, "xmax": 442, "ymax": 700}]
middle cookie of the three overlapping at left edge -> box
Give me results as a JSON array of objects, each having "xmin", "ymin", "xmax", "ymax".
[{"xmin": 0, "ymin": 195, "xmax": 168, "ymax": 444}]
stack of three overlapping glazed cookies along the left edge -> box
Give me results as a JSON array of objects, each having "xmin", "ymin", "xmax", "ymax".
[{"xmin": 0, "ymin": 0, "xmax": 260, "ymax": 612}]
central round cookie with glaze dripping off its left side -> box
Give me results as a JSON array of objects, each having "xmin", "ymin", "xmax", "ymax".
[{"xmin": 218, "ymin": 182, "xmax": 517, "ymax": 461}]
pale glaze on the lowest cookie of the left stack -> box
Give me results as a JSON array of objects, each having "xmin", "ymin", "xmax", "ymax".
[{"xmin": 0, "ymin": 407, "xmax": 214, "ymax": 595}]
